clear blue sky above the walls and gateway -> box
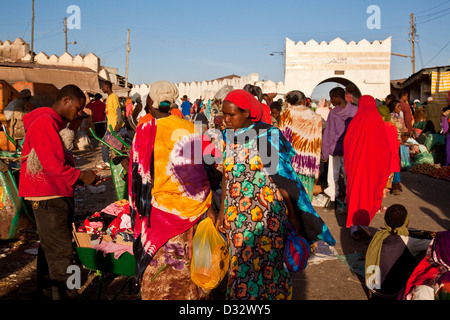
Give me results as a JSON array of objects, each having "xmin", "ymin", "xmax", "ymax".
[{"xmin": 0, "ymin": 0, "xmax": 450, "ymax": 99}]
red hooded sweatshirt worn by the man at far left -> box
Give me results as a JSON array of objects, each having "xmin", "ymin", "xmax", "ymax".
[{"xmin": 19, "ymin": 107, "xmax": 80, "ymax": 197}]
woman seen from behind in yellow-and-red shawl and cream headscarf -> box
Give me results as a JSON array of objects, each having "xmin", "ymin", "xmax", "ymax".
[{"xmin": 129, "ymin": 81, "xmax": 215, "ymax": 300}]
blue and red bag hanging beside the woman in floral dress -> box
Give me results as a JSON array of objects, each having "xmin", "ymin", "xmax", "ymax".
[{"xmin": 283, "ymin": 223, "xmax": 310, "ymax": 272}]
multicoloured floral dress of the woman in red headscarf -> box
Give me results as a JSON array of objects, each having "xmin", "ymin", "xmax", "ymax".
[{"xmin": 224, "ymin": 136, "xmax": 292, "ymax": 300}]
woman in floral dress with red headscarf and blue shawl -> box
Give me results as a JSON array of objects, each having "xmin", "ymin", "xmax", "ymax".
[{"xmin": 218, "ymin": 90, "xmax": 335, "ymax": 300}]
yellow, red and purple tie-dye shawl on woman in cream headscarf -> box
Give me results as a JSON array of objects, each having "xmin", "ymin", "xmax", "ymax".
[{"xmin": 129, "ymin": 116, "xmax": 211, "ymax": 278}]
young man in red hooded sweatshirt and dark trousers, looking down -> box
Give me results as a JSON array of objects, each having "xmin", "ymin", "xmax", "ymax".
[{"xmin": 19, "ymin": 85, "xmax": 97, "ymax": 300}]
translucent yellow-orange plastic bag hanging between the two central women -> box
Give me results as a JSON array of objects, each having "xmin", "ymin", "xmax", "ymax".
[{"xmin": 191, "ymin": 217, "xmax": 230, "ymax": 290}]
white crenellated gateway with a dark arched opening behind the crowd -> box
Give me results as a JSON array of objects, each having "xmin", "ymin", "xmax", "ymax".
[{"xmin": 284, "ymin": 37, "xmax": 391, "ymax": 100}]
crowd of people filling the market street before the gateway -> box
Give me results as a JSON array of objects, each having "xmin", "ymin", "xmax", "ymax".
[{"xmin": 13, "ymin": 81, "xmax": 450, "ymax": 299}]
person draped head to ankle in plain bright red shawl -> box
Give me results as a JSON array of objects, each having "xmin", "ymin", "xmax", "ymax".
[{"xmin": 344, "ymin": 95, "xmax": 391, "ymax": 239}]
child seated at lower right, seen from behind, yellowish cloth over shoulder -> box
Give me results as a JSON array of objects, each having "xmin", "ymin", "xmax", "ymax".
[{"xmin": 365, "ymin": 204, "xmax": 431, "ymax": 299}]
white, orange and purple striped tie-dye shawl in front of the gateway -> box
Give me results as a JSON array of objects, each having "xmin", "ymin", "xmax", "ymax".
[{"xmin": 278, "ymin": 106, "xmax": 322, "ymax": 178}]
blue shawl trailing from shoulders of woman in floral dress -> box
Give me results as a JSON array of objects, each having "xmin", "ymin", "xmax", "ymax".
[{"xmin": 224, "ymin": 122, "xmax": 336, "ymax": 246}]
